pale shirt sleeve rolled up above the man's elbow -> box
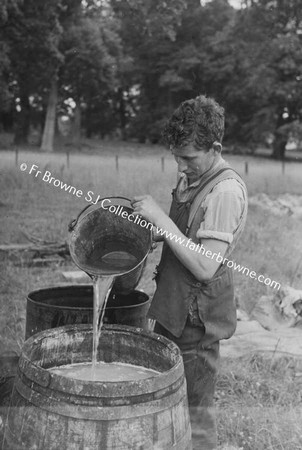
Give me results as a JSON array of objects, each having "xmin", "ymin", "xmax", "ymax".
[{"xmin": 196, "ymin": 180, "xmax": 244, "ymax": 244}]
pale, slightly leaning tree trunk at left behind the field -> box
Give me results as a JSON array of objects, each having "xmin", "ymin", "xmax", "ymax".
[{"xmin": 41, "ymin": 75, "xmax": 58, "ymax": 152}]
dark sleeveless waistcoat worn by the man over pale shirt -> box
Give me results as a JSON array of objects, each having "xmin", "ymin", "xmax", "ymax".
[{"xmin": 148, "ymin": 166, "xmax": 244, "ymax": 346}]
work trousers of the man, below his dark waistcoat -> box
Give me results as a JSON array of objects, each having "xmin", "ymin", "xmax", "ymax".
[{"xmin": 154, "ymin": 315, "xmax": 219, "ymax": 450}]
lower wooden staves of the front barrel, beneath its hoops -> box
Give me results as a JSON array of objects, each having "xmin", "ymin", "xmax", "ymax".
[{"xmin": 5, "ymin": 404, "xmax": 191, "ymax": 450}]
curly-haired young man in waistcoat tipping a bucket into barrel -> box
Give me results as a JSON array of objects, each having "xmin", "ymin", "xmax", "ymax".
[{"xmin": 133, "ymin": 96, "xmax": 247, "ymax": 450}]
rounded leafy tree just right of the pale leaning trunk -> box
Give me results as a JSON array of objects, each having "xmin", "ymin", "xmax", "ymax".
[{"xmin": 59, "ymin": 5, "xmax": 121, "ymax": 142}]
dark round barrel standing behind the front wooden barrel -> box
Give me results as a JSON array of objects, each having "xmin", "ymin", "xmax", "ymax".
[{"xmin": 25, "ymin": 285, "xmax": 150, "ymax": 339}]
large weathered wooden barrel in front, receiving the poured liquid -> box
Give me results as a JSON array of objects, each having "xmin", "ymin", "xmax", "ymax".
[{"xmin": 5, "ymin": 325, "xmax": 192, "ymax": 450}]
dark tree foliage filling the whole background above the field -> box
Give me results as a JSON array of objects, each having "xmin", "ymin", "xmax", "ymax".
[{"xmin": 0, "ymin": 0, "xmax": 302, "ymax": 157}]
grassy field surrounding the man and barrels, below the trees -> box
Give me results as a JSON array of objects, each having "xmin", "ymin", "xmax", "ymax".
[{"xmin": 0, "ymin": 143, "xmax": 302, "ymax": 450}]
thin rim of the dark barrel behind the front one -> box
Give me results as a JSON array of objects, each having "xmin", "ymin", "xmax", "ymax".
[{"xmin": 27, "ymin": 284, "xmax": 151, "ymax": 311}]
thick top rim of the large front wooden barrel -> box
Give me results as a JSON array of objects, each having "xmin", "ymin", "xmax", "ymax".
[{"xmin": 18, "ymin": 324, "xmax": 184, "ymax": 398}]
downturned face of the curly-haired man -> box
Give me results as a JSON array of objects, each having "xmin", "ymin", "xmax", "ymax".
[{"xmin": 172, "ymin": 144, "xmax": 216, "ymax": 183}]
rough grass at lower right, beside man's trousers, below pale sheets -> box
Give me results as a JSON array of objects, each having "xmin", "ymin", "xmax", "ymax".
[{"xmin": 216, "ymin": 355, "xmax": 302, "ymax": 450}]
